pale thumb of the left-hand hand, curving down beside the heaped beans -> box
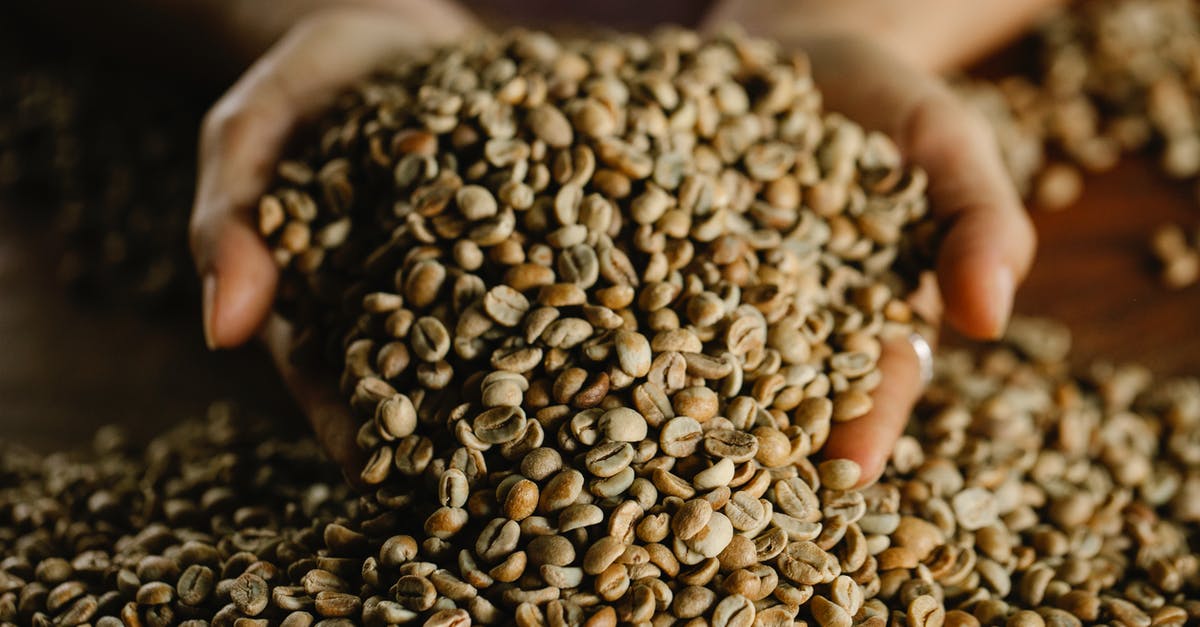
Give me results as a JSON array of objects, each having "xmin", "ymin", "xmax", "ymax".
[{"xmin": 191, "ymin": 4, "xmax": 474, "ymax": 347}]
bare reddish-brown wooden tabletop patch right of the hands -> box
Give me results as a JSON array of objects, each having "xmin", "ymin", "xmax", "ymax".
[{"xmin": 1016, "ymin": 157, "xmax": 1200, "ymax": 375}]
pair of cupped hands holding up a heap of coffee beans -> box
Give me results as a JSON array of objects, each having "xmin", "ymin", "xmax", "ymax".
[{"xmin": 191, "ymin": 0, "xmax": 1034, "ymax": 484}]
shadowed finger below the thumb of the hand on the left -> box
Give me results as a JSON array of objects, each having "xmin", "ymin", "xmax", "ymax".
[{"xmin": 262, "ymin": 316, "xmax": 365, "ymax": 485}]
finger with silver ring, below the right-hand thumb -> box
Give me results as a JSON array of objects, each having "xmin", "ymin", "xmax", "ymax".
[{"xmin": 822, "ymin": 338, "xmax": 922, "ymax": 486}]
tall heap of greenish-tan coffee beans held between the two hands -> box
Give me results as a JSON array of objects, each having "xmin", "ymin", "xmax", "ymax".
[{"xmin": 258, "ymin": 23, "xmax": 930, "ymax": 625}]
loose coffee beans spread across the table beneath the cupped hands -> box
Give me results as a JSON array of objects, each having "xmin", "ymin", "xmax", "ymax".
[{"xmin": 0, "ymin": 320, "xmax": 1200, "ymax": 627}]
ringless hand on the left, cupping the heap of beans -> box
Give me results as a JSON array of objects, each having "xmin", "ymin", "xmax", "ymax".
[{"xmin": 191, "ymin": 0, "xmax": 480, "ymax": 479}]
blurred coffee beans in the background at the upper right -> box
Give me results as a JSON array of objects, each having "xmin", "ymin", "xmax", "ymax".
[{"xmin": 960, "ymin": 0, "xmax": 1200, "ymax": 288}]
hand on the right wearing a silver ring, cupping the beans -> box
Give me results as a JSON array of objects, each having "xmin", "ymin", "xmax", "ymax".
[{"xmin": 763, "ymin": 35, "xmax": 1036, "ymax": 484}]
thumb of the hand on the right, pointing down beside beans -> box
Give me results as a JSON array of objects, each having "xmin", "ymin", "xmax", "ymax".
[{"xmin": 800, "ymin": 37, "xmax": 1036, "ymax": 338}]
